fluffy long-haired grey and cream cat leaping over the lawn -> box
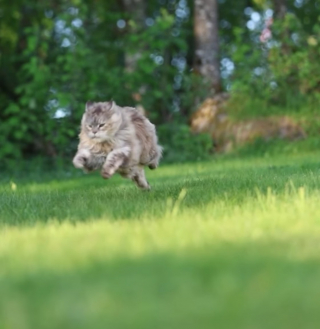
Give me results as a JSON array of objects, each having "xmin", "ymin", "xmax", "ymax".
[{"xmin": 73, "ymin": 101, "xmax": 162, "ymax": 189}]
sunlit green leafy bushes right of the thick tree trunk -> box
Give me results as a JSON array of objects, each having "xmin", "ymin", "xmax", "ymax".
[{"xmin": 230, "ymin": 14, "xmax": 320, "ymax": 118}]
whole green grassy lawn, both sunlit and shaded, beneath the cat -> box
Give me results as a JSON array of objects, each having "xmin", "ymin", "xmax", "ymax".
[{"xmin": 0, "ymin": 153, "xmax": 320, "ymax": 329}]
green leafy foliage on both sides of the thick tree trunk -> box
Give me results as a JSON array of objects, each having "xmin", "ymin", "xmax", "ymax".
[{"xmin": 0, "ymin": 0, "xmax": 320, "ymax": 166}]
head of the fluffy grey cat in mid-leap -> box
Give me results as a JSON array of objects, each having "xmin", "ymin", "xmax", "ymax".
[{"xmin": 81, "ymin": 101, "xmax": 122, "ymax": 142}]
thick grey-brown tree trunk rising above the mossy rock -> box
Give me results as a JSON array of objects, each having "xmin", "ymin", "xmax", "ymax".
[{"xmin": 194, "ymin": 0, "xmax": 221, "ymax": 94}]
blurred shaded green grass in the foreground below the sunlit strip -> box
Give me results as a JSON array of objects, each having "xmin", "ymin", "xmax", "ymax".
[{"xmin": 0, "ymin": 243, "xmax": 320, "ymax": 329}]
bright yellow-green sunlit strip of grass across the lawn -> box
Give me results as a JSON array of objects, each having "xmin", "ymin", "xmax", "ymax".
[{"xmin": 0, "ymin": 188, "xmax": 320, "ymax": 276}]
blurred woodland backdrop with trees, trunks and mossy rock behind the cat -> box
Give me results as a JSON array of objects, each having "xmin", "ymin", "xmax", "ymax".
[{"xmin": 0, "ymin": 0, "xmax": 320, "ymax": 168}]
